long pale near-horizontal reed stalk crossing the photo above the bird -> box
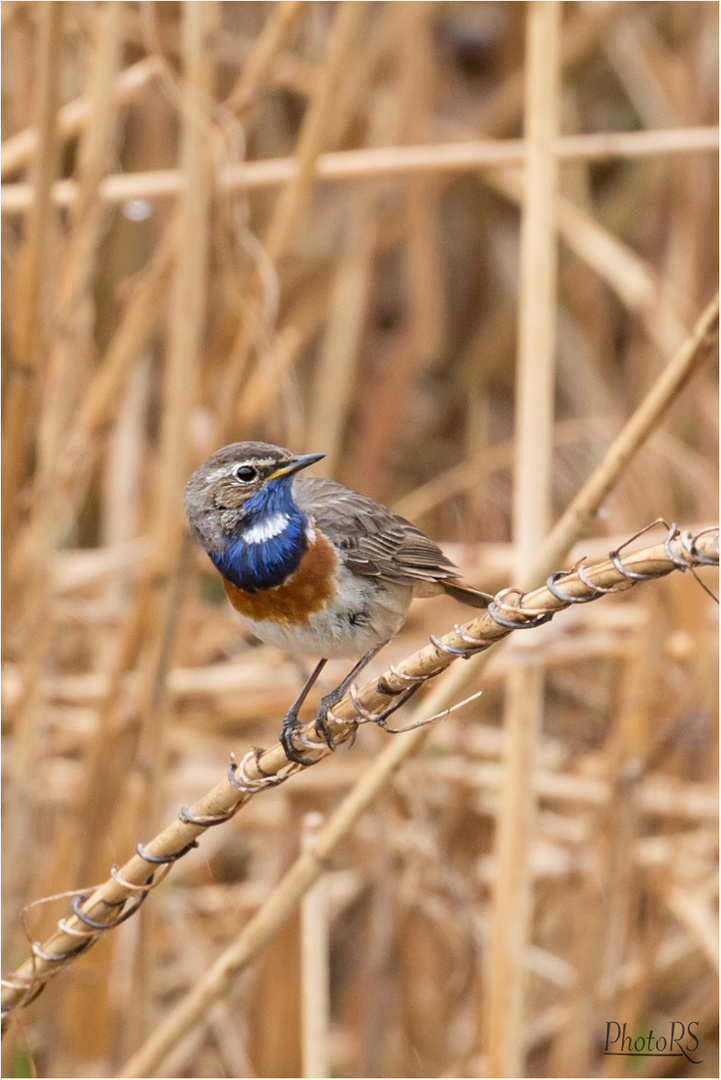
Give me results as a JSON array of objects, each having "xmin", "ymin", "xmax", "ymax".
[{"xmin": 0, "ymin": 126, "xmax": 719, "ymax": 214}]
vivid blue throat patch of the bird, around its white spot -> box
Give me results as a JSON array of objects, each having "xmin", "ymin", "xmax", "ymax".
[{"xmin": 210, "ymin": 476, "xmax": 308, "ymax": 593}]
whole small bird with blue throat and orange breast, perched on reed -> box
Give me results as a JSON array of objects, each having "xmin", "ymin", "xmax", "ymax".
[{"xmin": 186, "ymin": 443, "xmax": 492, "ymax": 765}]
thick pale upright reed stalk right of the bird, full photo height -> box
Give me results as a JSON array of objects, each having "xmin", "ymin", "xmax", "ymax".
[{"xmin": 484, "ymin": 6, "xmax": 561, "ymax": 1077}]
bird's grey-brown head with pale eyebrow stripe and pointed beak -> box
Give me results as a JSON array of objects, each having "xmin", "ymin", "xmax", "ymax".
[{"xmin": 185, "ymin": 443, "xmax": 325, "ymax": 554}]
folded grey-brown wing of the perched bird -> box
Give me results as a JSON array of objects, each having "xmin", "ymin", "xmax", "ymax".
[{"xmin": 293, "ymin": 476, "xmax": 460, "ymax": 584}]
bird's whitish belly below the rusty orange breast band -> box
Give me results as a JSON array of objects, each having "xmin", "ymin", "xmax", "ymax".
[{"xmin": 240, "ymin": 569, "xmax": 413, "ymax": 660}]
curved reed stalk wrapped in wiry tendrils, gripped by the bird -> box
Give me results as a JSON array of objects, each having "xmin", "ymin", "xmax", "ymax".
[{"xmin": 2, "ymin": 523, "xmax": 719, "ymax": 1011}]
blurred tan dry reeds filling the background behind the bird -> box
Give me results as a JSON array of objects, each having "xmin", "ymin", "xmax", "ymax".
[{"xmin": 1, "ymin": 0, "xmax": 718, "ymax": 1077}]
